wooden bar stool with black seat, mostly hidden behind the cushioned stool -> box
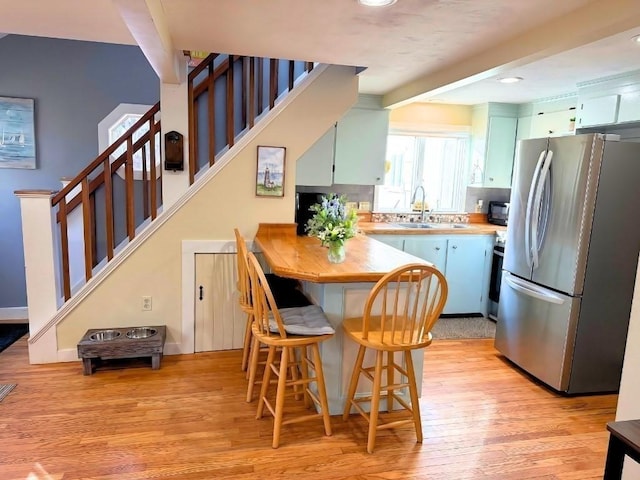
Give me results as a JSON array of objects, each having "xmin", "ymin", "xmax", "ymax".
[{"xmin": 233, "ymin": 228, "xmax": 311, "ymax": 394}]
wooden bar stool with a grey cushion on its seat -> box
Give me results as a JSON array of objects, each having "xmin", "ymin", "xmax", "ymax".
[{"xmin": 247, "ymin": 253, "xmax": 335, "ymax": 448}]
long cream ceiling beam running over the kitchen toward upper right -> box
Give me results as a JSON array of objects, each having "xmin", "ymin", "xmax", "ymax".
[{"xmin": 382, "ymin": 0, "xmax": 640, "ymax": 108}]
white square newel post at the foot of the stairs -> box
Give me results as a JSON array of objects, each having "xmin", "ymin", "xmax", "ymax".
[{"xmin": 14, "ymin": 190, "xmax": 59, "ymax": 340}]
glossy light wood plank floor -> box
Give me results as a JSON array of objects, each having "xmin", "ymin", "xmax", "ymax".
[{"xmin": 0, "ymin": 338, "xmax": 617, "ymax": 480}]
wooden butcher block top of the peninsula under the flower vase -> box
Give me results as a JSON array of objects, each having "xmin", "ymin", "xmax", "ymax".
[{"xmin": 255, "ymin": 223, "xmax": 431, "ymax": 283}]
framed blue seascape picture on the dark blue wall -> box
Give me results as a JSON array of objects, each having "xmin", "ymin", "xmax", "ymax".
[{"xmin": 0, "ymin": 97, "xmax": 36, "ymax": 168}]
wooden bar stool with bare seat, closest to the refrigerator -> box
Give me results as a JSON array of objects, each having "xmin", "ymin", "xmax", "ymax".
[{"xmin": 342, "ymin": 263, "xmax": 448, "ymax": 453}]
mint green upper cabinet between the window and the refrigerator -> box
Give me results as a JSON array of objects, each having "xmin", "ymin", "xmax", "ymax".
[{"xmin": 470, "ymin": 103, "xmax": 518, "ymax": 188}]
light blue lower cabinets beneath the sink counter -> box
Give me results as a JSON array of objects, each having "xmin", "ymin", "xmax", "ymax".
[{"xmin": 371, "ymin": 234, "xmax": 494, "ymax": 317}]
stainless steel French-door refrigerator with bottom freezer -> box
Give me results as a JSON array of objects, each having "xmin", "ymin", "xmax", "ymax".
[{"xmin": 495, "ymin": 134, "xmax": 640, "ymax": 394}]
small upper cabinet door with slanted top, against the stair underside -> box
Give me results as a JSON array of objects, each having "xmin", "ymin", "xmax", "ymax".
[{"xmin": 296, "ymin": 125, "xmax": 336, "ymax": 187}]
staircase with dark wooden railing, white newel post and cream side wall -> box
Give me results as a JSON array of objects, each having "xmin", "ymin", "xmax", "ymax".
[{"xmin": 19, "ymin": 60, "xmax": 358, "ymax": 363}]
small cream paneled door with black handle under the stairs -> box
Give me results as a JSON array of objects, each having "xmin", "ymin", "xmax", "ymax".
[{"xmin": 194, "ymin": 253, "xmax": 246, "ymax": 352}]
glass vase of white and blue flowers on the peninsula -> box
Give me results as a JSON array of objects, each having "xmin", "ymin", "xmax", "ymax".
[{"xmin": 305, "ymin": 194, "xmax": 358, "ymax": 263}]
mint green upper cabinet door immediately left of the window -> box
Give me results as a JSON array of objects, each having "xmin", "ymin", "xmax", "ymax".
[{"xmin": 333, "ymin": 108, "xmax": 389, "ymax": 185}]
